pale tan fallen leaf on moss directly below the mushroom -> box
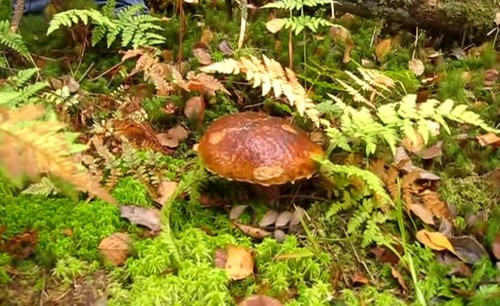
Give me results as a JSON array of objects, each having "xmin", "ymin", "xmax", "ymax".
[{"xmin": 224, "ymin": 245, "xmax": 254, "ymax": 280}]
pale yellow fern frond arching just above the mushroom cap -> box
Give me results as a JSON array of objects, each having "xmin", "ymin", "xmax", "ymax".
[{"xmin": 200, "ymin": 55, "xmax": 320, "ymax": 126}]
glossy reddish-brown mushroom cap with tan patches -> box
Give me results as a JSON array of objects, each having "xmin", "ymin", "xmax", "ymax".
[{"xmin": 198, "ymin": 112, "xmax": 323, "ymax": 186}]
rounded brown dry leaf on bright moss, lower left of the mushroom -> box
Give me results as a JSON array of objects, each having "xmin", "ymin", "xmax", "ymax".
[{"xmin": 99, "ymin": 233, "xmax": 132, "ymax": 266}]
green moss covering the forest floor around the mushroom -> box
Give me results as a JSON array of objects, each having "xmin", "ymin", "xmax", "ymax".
[{"xmin": 0, "ymin": 4, "xmax": 500, "ymax": 306}]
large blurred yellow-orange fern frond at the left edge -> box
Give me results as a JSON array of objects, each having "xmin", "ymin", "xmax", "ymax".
[{"xmin": 0, "ymin": 105, "xmax": 117, "ymax": 205}]
